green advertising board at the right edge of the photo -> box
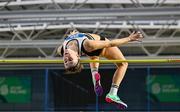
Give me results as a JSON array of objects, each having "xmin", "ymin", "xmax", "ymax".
[{"xmin": 147, "ymin": 75, "xmax": 180, "ymax": 102}]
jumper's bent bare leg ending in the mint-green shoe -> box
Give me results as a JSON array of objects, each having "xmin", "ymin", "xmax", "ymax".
[{"xmin": 103, "ymin": 47, "xmax": 128, "ymax": 108}]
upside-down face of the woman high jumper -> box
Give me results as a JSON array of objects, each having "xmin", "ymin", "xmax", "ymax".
[{"xmin": 63, "ymin": 49, "xmax": 79, "ymax": 69}]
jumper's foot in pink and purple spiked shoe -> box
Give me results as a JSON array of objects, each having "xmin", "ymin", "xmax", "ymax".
[{"xmin": 94, "ymin": 73, "xmax": 103, "ymax": 96}]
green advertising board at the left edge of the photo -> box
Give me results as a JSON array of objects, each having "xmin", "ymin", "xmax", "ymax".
[{"xmin": 0, "ymin": 76, "xmax": 31, "ymax": 103}]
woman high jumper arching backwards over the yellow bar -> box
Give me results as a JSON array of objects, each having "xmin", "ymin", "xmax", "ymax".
[{"xmin": 57, "ymin": 30, "xmax": 143, "ymax": 109}]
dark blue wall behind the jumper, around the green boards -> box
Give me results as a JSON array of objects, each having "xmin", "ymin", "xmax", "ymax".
[{"xmin": 0, "ymin": 68, "xmax": 180, "ymax": 111}]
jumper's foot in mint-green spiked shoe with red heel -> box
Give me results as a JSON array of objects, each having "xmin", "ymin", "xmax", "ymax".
[{"xmin": 106, "ymin": 94, "xmax": 127, "ymax": 109}]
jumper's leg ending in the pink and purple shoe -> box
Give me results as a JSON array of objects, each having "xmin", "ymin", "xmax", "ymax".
[{"xmin": 90, "ymin": 56, "xmax": 103, "ymax": 96}]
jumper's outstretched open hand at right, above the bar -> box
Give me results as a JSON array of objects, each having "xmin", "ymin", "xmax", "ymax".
[{"xmin": 128, "ymin": 31, "xmax": 144, "ymax": 41}]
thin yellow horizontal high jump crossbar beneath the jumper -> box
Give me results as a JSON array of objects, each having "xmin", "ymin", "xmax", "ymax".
[{"xmin": 0, "ymin": 59, "xmax": 180, "ymax": 64}]
